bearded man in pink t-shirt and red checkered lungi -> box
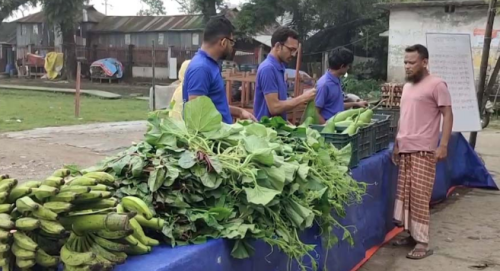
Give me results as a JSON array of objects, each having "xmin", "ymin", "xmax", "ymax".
[{"xmin": 393, "ymin": 45, "xmax": 453, "ymax": 260}]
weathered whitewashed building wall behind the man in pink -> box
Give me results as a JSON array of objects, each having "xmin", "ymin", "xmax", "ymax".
[{"xmin": 387, "ymin": 7, "xmax": 500, "ymax": 82}]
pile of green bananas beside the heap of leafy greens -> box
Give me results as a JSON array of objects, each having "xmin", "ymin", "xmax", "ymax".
[{"xmin": 0, "ymin": 172, "xmax": 159, "ymax": 271}]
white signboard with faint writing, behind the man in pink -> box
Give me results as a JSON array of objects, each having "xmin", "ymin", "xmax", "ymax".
[{"xmin": 427, "ymin": 33, "xmax": 481, "ymax": 132}]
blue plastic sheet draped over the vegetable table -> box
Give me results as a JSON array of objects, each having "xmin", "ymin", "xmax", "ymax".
[{"xmin": 115, "ymin": 134, "xmax": 498, "ymax": 271}]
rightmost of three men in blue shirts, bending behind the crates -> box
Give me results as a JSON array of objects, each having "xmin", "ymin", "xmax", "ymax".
[{"xmin": 315, "ymin": 48, "xmax": 368, "ymax": 124}]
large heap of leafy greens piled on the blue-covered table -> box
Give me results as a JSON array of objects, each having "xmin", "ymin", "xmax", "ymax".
[{"xmin": 88, "ymin": 97, "xmax": 366, "ymax": 269}]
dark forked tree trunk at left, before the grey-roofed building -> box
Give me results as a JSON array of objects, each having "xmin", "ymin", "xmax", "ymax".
[{"xmin": 42, "ymin": 0, "xmax": 84, "ymax": 79}]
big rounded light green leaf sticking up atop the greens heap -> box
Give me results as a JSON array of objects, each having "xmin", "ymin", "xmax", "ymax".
[{"xmin": 184, "ymin": 96, "xmax": 222, "ymax": 132}]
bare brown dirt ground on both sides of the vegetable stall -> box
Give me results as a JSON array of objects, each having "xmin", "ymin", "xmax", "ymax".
[{"xmin": 0, "ymin": 122, "xmax": 500, "ymax": 271}]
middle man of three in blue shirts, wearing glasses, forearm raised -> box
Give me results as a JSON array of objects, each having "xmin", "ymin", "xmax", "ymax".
[{"xmin": 254, "ymin": 27, "xmax": 316, "ymax": 120}]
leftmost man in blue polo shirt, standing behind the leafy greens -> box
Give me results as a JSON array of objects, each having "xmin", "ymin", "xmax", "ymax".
[{"xmin": 182, "ymin": 16, "xmax": 256, "ymax": 124}]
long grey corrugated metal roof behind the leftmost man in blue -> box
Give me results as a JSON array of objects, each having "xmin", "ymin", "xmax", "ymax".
[{"xmin": 92, "ymin": 15, "xmax": 204, "ymax": 33}]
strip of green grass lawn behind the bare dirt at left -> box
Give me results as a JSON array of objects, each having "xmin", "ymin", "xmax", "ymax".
[{"xmin": 0, "ymin": 89, "xmax": 149, "ymax": 132}]
